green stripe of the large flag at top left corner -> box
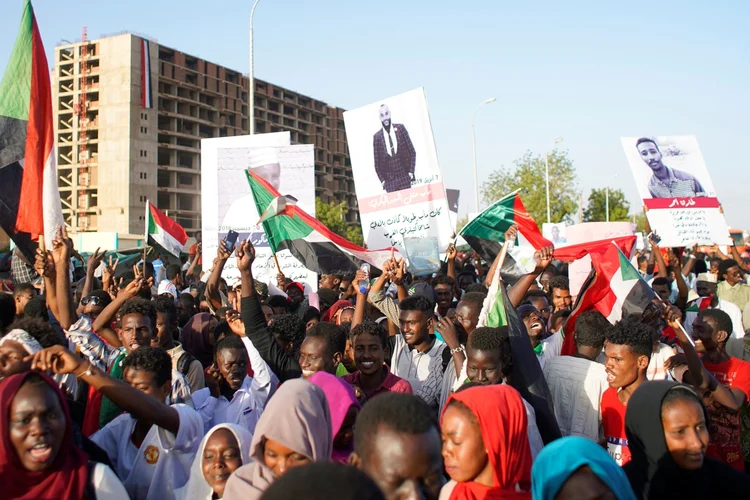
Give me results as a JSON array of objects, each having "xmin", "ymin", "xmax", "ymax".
[{"xmin": 0, "ymin": 0, "xmax": 34, "ymax": 120}]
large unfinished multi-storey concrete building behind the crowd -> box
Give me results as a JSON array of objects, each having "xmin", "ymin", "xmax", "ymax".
[{"xmin": 52, "ymin": 29, "xmax": 359, "ymax": 246}]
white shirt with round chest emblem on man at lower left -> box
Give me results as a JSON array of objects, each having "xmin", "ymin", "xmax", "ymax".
[{"xmin": 91, "ymin": 404, "xmax": 203, "ymax": 500}]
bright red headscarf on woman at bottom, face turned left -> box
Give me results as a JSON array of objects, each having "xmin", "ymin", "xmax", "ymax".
[{"xmin": 443, "ymin": 385, "xmax": 531, "ymax": 500}]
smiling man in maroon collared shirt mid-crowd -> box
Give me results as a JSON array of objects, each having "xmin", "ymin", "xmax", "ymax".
[{"xmin": 341, "ymin": 321, "xmax": 412, "ymax": 401}]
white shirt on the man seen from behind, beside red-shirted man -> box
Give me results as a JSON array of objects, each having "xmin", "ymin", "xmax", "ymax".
[{"xmin": 544, "ymin": 356, "xmax": 609, "ymax": 441}]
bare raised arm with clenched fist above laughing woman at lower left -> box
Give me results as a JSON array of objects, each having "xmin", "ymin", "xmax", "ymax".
[{"xmin": 31, "ymin": 346, "xmax": 180, "ymax": 435}]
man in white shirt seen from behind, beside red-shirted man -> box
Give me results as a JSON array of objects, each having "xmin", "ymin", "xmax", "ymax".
[{"xmin": 544, "ymin": 311, "xmax": 612, "ymax": 442}]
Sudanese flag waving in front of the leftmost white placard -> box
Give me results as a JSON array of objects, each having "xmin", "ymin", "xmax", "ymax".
[{"xmin": 247, "ymin": 170, "xmax": 394, "ymax": 274}]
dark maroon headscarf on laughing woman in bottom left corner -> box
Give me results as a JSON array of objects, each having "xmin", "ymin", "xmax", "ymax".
[{"xmin": 0, "ymin": 372, "xmax": 89, "ymax": 499}]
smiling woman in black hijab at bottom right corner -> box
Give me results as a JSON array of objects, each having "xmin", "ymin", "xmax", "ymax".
[{"xmin": 624, "ymin": 381, "xmax": 750, "ymax": 500}]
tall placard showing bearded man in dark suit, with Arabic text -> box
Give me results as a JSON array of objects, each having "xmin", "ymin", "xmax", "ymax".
[{"xmin": 344, "ymin": 88, "xmax": 453, "ymax": 251}]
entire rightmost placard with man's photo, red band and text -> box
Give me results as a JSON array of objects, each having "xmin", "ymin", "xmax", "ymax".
[{"xmin": 621, "ymin": 135, "xmax": 729, "ymax": 247}]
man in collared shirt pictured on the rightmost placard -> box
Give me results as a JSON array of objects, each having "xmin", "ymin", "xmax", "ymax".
[{"xmin": 635, "ymin": 137, "xmax": 706, "ymax": 198}]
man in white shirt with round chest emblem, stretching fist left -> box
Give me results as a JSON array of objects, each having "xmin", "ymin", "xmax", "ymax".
[{"xmin": 34, "ymin": 346, "xmax": 203, "ymax": 500}]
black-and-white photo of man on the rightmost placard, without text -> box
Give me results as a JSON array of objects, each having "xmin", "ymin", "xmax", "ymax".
[{"xmin": 622, "ymin": 135, "xmax": 716, "ymax": 200}]
